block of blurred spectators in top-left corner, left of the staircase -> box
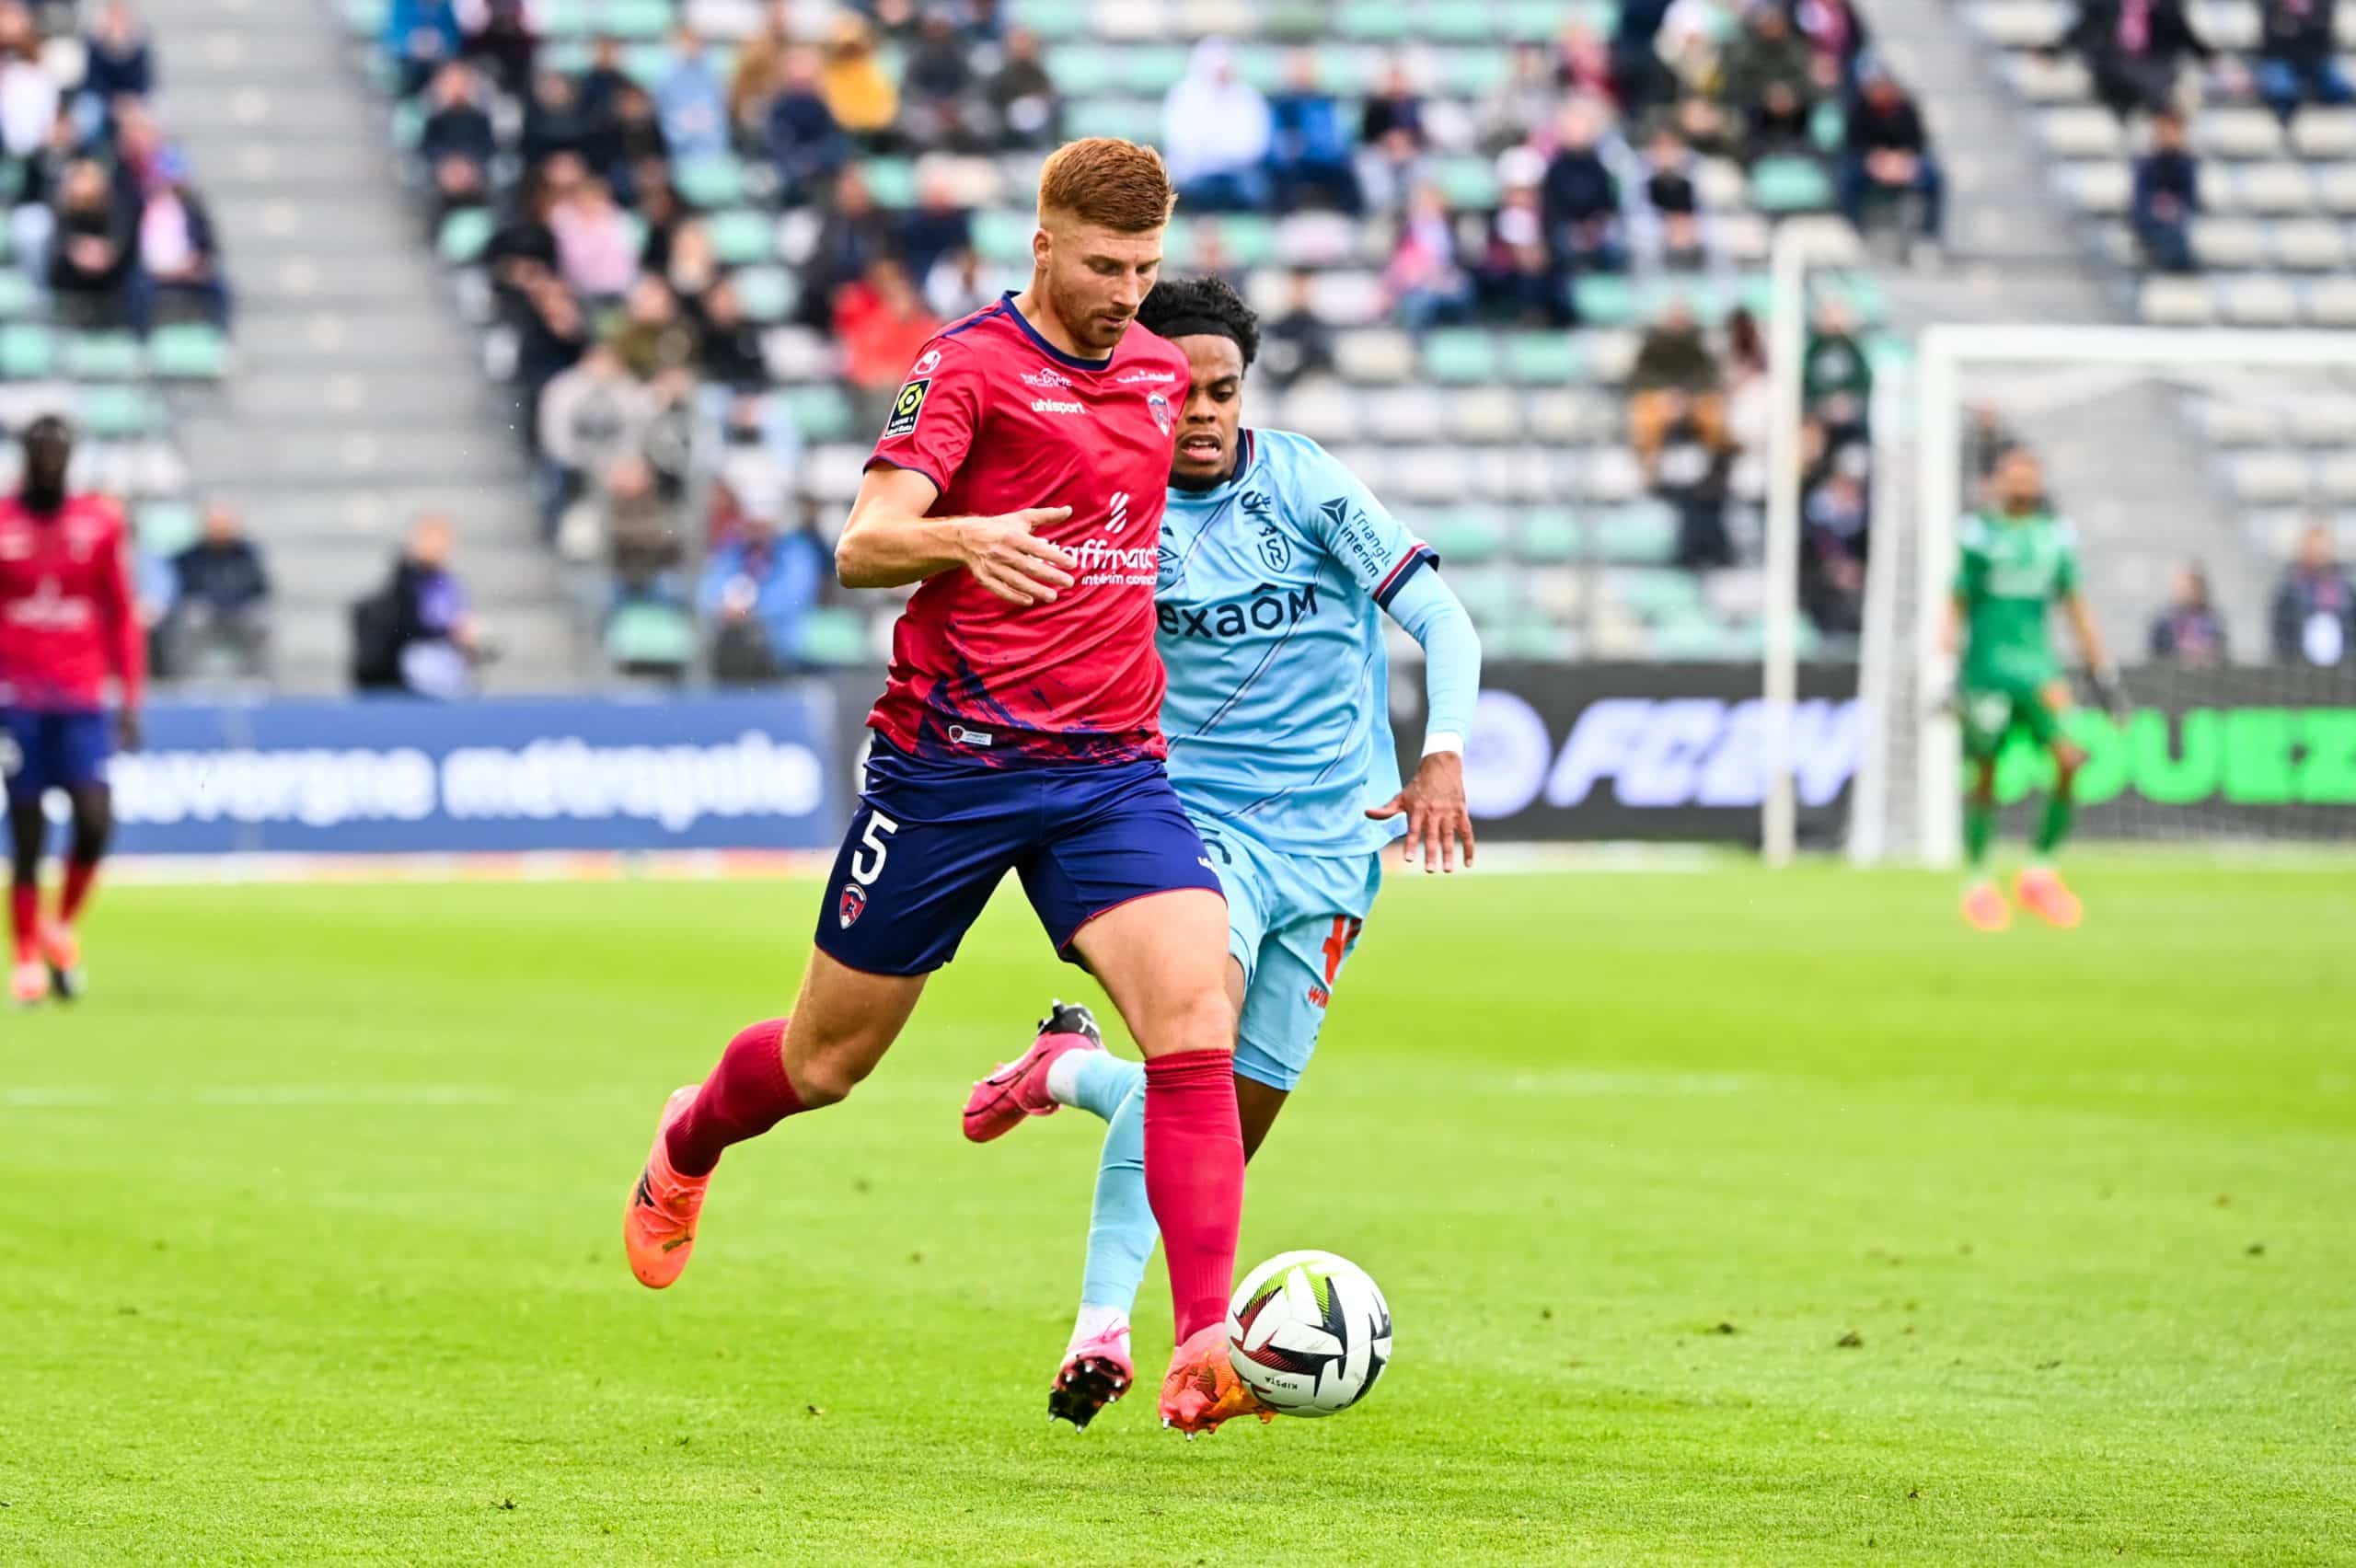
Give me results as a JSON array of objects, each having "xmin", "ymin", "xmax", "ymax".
[{"xmin": 0, "ymin": 0, "xmax": 228, "ymax": 334}]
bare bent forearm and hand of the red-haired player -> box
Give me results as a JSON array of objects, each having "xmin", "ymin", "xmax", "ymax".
[{"xmin": 834, "ymin": 468, "xmax": 1074, "ymax": 605}]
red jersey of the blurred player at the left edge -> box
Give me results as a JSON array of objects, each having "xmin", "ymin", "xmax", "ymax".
[{"xmin": 0, "ymin": 494, "xmax": 146, "ymax": 711}]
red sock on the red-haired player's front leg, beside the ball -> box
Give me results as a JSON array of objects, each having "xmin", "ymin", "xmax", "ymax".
[{"xmin": 1145, "ymin": 1050, "xmax": 1244, "ymax": 1344}]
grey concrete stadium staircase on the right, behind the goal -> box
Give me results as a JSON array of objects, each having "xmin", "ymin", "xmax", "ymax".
[{"xmin": 1866, "ymin": 0, "xmax": 2267, "ymax": 652}]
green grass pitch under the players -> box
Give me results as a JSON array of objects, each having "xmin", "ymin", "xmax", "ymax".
[{"xmin": 0, "ymin": 859, "xmax": 2356, "ymax": 1563}]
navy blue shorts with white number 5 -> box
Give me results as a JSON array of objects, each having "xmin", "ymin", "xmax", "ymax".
[{"xmin": 817, "ymin": 737, "xmax": 1220, "ymax": 974}]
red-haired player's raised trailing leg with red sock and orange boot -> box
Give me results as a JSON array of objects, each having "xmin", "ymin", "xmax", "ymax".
[{"xmin": 622, "ymin": 949, "xmax": 924, "ymax": 1290}]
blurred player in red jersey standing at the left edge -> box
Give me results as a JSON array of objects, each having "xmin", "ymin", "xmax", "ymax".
[{"xmin": 0, "ymin": 417, "xmax": 146, "ymax": 1006}]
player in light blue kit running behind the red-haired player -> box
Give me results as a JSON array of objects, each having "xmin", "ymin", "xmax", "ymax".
[{"xmin": 966, "ymin": 278, "xmax": 1480, "ymax": 1426}]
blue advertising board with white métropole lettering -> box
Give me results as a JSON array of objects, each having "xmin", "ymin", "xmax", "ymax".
[{"xmin": 113, "ymin": 680, "xmax": 850, "ymax": 855}]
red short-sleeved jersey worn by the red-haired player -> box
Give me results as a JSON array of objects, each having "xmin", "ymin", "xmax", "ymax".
[{"xmin": 867, "ymin": 294, "xmax": 1187, "ymax": 763}]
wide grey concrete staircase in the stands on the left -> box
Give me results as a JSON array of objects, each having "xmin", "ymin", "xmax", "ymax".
[{"xmin": 146, "ymin": 0, "xmax": 589, "ymax": 692}]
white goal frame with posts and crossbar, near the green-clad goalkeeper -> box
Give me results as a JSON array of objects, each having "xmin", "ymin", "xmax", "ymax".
[{"xmin": 1760, "ymin": 262, "xmax": 2356, "ymax": 867}]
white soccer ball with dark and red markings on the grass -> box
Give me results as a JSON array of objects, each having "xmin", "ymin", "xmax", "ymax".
[{"xmin": 1228, "ymin": 1252, "xmax": 1390, "ymax": 1415}]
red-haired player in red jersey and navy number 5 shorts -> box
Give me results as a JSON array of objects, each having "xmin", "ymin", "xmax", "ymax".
[{"xmin": 624, "ymin": 136, "xmax": 1244, "ymax": 1434}]
